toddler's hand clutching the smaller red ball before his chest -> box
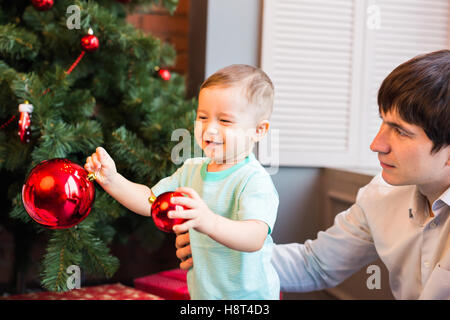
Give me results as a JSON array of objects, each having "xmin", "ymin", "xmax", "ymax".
[{"xmin": 168, "ymin": 187, "xmax": 217, "ymax": 235}]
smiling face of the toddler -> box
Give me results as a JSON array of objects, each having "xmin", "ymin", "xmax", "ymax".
[{"xmin": 194, "ymin": 87, "xmax": 259, "ymax": 164}]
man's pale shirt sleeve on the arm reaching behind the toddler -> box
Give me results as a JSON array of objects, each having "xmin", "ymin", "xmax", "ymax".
[{"xmin": 272, "ymin": 204, "xmax": 378, "ymax": 292}]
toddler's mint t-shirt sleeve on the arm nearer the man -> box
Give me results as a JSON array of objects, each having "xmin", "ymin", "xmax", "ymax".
[{"xmin": 237, "ymin": 175, "xmax": 279, "ymax": 234}]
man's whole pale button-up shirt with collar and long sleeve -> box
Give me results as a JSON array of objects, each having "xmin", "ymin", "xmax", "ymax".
[{"xmin": 272, "ymin": 174, "xmax": 450, "ymax": 299}]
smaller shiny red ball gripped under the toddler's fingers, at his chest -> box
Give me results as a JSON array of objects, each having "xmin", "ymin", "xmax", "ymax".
[{"xmin": 150, "ymin": 192, "xmax": 186, "ymax": 232}]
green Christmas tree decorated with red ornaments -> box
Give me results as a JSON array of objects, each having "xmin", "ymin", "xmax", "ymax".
[{"xmin": 0, "ymin": 0, "xmax": 196, "ymax": 291}]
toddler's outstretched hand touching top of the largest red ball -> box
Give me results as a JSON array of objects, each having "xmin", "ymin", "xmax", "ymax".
[{"xmin": 84, "ymin": 147, "xmax": 117, "ymax": 185}]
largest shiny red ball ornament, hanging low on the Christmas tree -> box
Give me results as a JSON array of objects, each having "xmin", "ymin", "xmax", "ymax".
[{"xmin": 22, "ymin": 158, "xmax": 95, "ymax": 229}]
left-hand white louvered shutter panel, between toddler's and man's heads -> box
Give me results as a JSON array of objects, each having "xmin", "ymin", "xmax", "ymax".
[{"xmin": 259, "ymin": 0, "xmax": 359, "ymax": 166}]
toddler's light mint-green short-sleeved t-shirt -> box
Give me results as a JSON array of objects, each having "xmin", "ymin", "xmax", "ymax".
[{"xmin": 152, "ymin": 154, "xmax": 280, "ymax": 300}]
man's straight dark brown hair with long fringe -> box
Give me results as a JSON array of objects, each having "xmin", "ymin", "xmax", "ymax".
[{"xmin": 378, "ymin": 50, "xmax": 450, "ymax": 154}]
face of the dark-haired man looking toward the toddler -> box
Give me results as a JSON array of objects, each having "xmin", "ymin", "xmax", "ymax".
[{"xmin": 370, "ymin": 111, "xmax": 450, "ymax": 185}]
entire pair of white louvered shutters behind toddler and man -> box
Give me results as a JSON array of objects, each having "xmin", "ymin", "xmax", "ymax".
[{"xmin": 258, "ymin": 0, "xmax": 449, "ymax": 168}]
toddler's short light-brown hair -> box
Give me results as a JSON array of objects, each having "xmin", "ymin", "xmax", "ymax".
[{"xmin": 200, "ymin": 64, "xmax": 274, "ymax": 119}]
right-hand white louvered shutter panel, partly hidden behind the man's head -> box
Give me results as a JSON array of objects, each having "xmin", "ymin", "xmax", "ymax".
[{"xmin": 359, "ymin": 0, "xmax": 450, "ymax": 167}]
